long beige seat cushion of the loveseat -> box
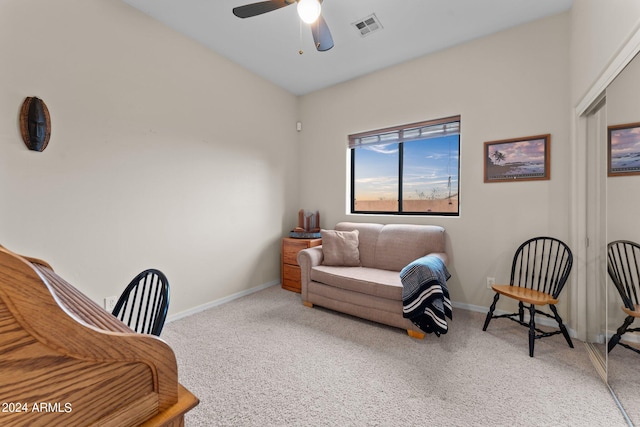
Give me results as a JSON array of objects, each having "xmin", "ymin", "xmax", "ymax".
[{"xmin": 311, "ymin": 265, "xmax": 402, "ymax": 301}]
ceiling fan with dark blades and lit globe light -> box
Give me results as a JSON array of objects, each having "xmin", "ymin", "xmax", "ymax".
[{"xmin": 233, "ymin": 0, "xmax": 333, "ymax": 52}]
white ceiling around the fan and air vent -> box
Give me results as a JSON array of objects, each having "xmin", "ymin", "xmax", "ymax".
[{"xmin": 123, "ymin": 0, "xmax": 573, "ymax": 95}]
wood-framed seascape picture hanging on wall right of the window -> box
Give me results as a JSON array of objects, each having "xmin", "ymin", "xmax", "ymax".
[{"xmin": 484, "ymin": 134, "xmax": 551, "ymax": 182}]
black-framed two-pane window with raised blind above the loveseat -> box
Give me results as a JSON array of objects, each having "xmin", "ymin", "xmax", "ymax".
[{"xmin": 349, "ymin": 116, "xmax": 460, "ymax": 216}]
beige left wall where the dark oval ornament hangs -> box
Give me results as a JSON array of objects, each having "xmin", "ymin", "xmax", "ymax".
[{"xmin": 0, "ymin": 0, "xmax": 298, "ymax": 314}]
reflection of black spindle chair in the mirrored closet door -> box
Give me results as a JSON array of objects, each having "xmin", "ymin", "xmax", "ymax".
[{"xmin": 607, "ymin": 240, "xmax": 640, "ymax": 354}]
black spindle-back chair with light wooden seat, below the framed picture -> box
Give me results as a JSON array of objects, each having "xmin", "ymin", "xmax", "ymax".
[{"xmin": 482, "ymin": 237, "xmax": 573, "ymax": 357}]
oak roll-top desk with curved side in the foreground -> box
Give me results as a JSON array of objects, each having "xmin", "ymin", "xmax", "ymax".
[{"xmin": 0, "ymin": 246, "xmax": 198, "ymax": 427}]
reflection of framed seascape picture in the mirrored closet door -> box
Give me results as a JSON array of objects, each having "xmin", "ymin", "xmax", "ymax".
[{"xmin": 607, "ymin": 123, "xmax": 640, "ymax": 176}]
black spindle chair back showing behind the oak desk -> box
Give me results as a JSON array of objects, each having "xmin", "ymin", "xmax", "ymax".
[{"xmin": 112, "ymin": 268, "xmax": 169, "ymax": 336}]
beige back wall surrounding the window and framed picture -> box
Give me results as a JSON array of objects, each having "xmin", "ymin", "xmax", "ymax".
[{"xmin": 300, "ymin": 13, "xmax": 570, "ymax": 314}]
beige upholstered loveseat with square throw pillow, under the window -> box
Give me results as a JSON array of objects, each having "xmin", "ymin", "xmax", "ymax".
[{"xmin": 298, "ymin": 222, "xmax": 448, "ymax": 338}]
